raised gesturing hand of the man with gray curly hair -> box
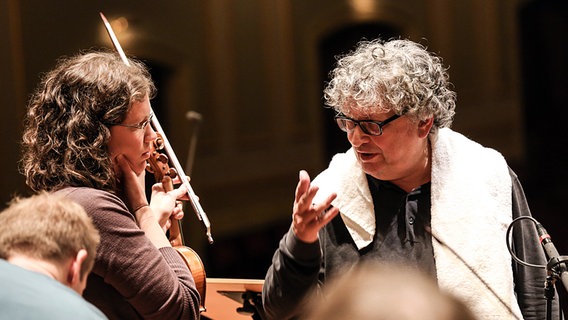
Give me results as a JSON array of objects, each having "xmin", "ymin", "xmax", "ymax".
[{"xmin": 292, "ymin": 170, "xmax": 339, "ymax": 243}]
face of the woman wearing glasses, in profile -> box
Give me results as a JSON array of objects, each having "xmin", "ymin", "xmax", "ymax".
[{"xmin": 108, "ymin": 97, "xmax": 157, "ymax": 174}]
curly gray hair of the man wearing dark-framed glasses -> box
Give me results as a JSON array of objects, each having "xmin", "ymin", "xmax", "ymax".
[{"xmin": 324, "ymin": 39, "xmax": 456, "ymax": 132}]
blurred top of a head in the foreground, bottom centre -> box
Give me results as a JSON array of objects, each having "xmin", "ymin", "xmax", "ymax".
[{"xmin": 302, "ymin": 262, "xmax": 476, "ymax": 320}]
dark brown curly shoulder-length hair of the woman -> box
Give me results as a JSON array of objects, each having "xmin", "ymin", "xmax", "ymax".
[{"xmin": 20, "ymin": 51, "xmax": 156, "ymax": 192}]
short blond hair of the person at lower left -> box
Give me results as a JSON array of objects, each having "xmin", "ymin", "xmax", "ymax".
[{"xmin": 0, "ymin": 192, "xmax": 100, "ymax": 278}]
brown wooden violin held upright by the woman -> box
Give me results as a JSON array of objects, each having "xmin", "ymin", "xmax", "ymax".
[{"xmin": 146, "ymin": 132, "xmax": 207, "ymax": 312}]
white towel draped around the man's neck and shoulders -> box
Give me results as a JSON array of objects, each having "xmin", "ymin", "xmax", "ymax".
[{"xmin": 313, "ymin": 128, "xmax": 522, "ymax": 319}]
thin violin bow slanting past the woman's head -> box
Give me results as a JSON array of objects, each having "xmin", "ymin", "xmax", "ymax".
[{"xmin": 99, "ymin": 12, "xmax": 213, "ymax": 244}]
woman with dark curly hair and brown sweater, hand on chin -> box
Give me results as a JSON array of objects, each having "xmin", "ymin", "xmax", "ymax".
[{"xmin": 21, "ymin": 52, "xmax": 200, "ymax": 319}]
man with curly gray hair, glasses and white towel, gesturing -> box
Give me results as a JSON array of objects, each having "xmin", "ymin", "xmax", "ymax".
[{"xmin": 263, "ymin": 39, "xmax": 558, "ymax": 319}]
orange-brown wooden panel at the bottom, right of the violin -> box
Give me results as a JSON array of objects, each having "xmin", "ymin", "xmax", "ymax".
[{"xmin": 201, "ymin": 278, "xmax": 264, "ymax": 320}]
